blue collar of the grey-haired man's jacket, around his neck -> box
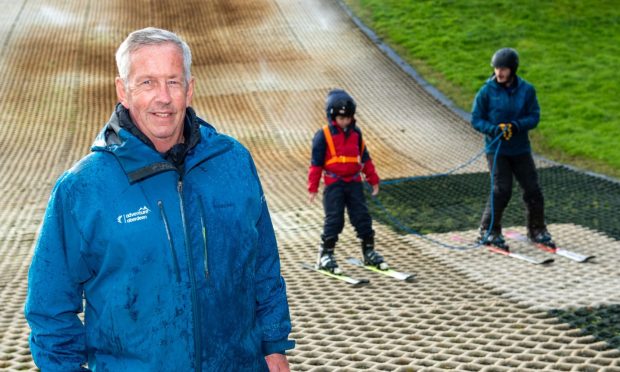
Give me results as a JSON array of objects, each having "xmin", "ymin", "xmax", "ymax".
[{"xmin": 91, "ymin": 104, "xmax": 233, "ymax": 183}]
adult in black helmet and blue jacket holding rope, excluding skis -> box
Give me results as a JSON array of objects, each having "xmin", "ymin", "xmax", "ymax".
[{"xmin": 471, "ymin": 48, "xmax": 555, "ymax": 251}]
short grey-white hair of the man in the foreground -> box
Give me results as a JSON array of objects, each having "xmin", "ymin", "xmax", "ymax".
[{"xmin": 116, "ymin": 27, "xmax": 192, "ymax": 83}]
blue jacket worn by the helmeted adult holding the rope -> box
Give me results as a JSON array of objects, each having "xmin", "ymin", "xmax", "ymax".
[{"xmin": 471, "ymin": 76, "xmax": 540, "ymax": 156}]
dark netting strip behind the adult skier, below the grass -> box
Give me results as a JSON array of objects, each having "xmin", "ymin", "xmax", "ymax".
[{"xmin": 368, "ymin": 160, "xmax": 620, "ymax": 239}]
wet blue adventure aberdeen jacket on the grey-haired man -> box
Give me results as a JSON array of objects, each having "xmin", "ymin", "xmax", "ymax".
[{"xmin": 25, "ymin": 109, "xmax": 294, "ymax": 372}]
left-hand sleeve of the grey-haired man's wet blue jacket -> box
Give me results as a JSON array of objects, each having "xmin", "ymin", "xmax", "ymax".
[{"xmin": 25, "ymin": 174, "xmax": 88, "ymax": 372}]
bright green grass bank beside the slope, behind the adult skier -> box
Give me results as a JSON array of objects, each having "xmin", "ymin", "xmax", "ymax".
[{"xmin": 345, "ymin": 0, "xmax": 620, "ymax": 177}]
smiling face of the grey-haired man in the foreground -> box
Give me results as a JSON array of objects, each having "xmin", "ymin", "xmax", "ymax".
[{"xmin": 116, "ymin": 43, "xmax": 194, "ymax": 152}]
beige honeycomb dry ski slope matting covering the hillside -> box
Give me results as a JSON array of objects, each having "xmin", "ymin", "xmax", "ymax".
[{"xmin": 0, "ymin": 0, "xmax": 620, "ymax": 371}]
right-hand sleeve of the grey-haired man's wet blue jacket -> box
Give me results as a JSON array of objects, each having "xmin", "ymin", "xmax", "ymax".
[{"xmin": 252, "ymin": 160, "xmax": 295, "ymax": 355}]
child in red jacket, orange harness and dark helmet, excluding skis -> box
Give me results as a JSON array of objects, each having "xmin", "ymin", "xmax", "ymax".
[{"xmin": 308, "ymin": 89, "xmax": 389, "ymax": 274}]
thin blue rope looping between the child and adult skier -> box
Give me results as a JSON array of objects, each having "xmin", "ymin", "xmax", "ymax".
[{"xmin": 366, "ymin": 133, "xmax": 503, "ymax": 251}]
